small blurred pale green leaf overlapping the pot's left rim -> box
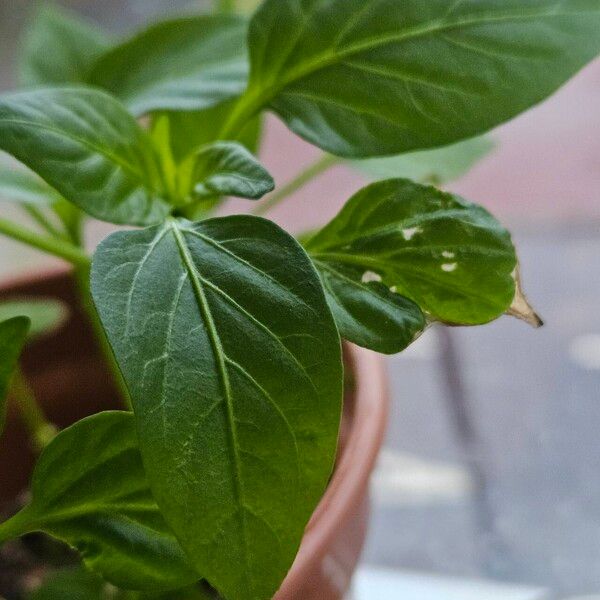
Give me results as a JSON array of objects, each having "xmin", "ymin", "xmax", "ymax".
[{"xmin": 0, "ymin": 298, "xmax": 69, "ymax": 340}]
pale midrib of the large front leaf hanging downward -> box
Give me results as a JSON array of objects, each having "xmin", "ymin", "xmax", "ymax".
[{"xmin": 170, "ymin": 220, "xmax": 252, "ymax": 589}]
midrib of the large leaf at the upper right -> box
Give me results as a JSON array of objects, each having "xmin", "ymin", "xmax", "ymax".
[{"xmin": 249, "ymin": 5, "xmax": 600, "ymax": 106}]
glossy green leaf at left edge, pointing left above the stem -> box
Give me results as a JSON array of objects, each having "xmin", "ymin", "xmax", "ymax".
[{"xmin": 0, "ymin": 88, "xmax": 170, "ymax": 225}]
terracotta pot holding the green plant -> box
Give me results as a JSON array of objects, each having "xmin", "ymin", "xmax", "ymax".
[{"xmin": 0, "ymin": 271, "xmax": 388, "ymax": 600}]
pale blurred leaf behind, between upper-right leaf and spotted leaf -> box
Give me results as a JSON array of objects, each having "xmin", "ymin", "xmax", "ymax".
[{"xmin": 350, "ymin": 136, "xmax": 494, "ymax": 186}]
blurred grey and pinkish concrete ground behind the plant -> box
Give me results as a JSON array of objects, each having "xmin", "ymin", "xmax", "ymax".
[{"xmin": 0, "ymin": 0, "xmax": 600, "ymax": 600}]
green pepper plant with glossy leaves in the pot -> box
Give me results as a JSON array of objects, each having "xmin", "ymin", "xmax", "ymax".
[{"xmin": 0, "ymin": 0, "xmax": 600, "ymax": 600}]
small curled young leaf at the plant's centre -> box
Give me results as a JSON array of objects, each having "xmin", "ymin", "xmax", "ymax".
[{"xmin": 191, "ymin": 142, "xmax": 275, "ymax": 200}]
